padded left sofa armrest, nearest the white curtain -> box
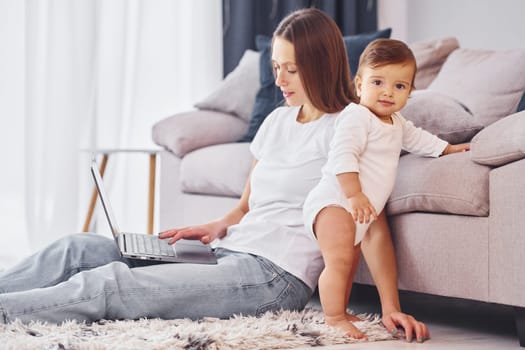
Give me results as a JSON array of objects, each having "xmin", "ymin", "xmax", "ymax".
[{"xmin": 152, "ymin": 110, "xmax": 248, "ymax": 158}]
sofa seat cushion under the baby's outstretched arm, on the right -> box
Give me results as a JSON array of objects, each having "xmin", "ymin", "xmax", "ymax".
[{"xmin": 386, "ymin": 152, "xmax": 491, "ymax": 216}]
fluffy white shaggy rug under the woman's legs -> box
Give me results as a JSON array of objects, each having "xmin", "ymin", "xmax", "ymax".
[{"xmin": 0, "ymin": 308, "xmax": 393, "ymax": 350}]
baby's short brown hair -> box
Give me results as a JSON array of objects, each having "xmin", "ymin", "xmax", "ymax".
[{"xmin": 356, "ymin": 39, "xmax": 416, "ymax": 89}]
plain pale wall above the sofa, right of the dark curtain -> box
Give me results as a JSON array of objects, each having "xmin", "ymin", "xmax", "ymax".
[{"xmin": 378, "ymin": 0, "xmax": 525, "ymax": 49}]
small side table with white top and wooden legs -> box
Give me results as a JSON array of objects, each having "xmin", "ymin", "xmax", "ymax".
[{"xmin": 82, "ymin": 148, "xmax": 161, "ymax": 235}]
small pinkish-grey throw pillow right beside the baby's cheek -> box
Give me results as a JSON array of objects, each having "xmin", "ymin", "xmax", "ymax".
[{"xmin": 401, "ymin": 90, "xmax": 483, "ymax": 144}]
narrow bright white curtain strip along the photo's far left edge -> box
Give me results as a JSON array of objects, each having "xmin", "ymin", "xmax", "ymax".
[{"xmin": 0, "ymin": 0, "xmax": 29, "ymax": 268}]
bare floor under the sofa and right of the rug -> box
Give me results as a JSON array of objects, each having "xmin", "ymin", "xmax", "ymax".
[{"xmin": 301, "ymin": 285, "xmax": 525, "ymax": 350}]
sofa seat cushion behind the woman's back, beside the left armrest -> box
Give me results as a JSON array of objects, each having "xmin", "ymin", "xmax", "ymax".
[{"xmin": 180, "ymin": 142, "xmax": 253, "ymax": 197}]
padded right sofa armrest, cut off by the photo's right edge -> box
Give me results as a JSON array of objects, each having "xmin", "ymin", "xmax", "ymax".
[{"xmin": 470, "ymin": 111, "xmax": 525, "ymax": 166}]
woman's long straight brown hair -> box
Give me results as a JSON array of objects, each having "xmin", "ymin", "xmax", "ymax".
[{"xmin": 273, "ymin": 8, "xmax": 357, "ymax": 113}]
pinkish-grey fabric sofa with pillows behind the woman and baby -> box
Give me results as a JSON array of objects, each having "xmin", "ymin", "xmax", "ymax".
[{"xmin": 152, "ymin": 37, "xmax": 525, "ymax": 346}]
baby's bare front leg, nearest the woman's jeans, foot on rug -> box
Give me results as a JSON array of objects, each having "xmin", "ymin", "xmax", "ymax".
[{"xmin": 314, "ymin": 207, "xmax": 365, "ymax": 339}]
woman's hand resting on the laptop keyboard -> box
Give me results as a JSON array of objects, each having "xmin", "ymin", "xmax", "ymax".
[{"xmin": 159, "ymin": 221, "xmax": 226, "ymax": 244}]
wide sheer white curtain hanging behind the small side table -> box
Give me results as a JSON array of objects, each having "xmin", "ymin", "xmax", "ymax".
[{"xmin": 0, "ymin": 0, "xmax": 222, "ymax": 263}]
